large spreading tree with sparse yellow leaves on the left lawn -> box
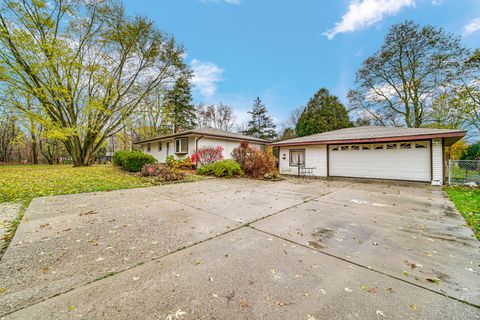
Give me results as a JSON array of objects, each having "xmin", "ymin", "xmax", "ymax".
[{"xmin": 0, "ymin": 0, "xmax": 185, "ymax": 166}]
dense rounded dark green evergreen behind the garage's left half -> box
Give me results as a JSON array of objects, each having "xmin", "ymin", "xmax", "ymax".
[{"xmin": 295, "ymin": 88, "xmax": 352, "ymax": 137}]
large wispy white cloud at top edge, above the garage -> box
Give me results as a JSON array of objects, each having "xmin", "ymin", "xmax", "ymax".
[{"xmin": 323, "ymin": 0, "xmax": 415, "ymax": 40}]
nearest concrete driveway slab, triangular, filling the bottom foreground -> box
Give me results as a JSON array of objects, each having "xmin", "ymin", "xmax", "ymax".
[{"xmin": 4, "ymin": 227, "xmax": 480, "ymax": 320}]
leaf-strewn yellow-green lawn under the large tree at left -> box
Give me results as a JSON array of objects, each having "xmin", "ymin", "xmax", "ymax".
[{"xmin": 0, "ymin": 165, "xmax": 159, "ymax": 202}]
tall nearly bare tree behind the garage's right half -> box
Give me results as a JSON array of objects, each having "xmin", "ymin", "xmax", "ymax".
[{"xmin": 348, "ymin": 21, "xmax": 468, "ymax": 127}]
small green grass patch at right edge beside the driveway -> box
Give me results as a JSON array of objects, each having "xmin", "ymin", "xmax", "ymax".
[{"xmin": 445, "ymin": 187, "xmax": 480, "ymax": 240}]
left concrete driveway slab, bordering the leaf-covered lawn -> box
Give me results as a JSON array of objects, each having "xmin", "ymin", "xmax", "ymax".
[{"xmin": 0, "ymin": 188, "xmax": 239, "ymax": 314}]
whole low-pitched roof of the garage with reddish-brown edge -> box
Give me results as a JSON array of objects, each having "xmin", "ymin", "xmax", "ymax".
[{"xmin": 273, "ymin": 126, "xmax": 465, "ymax": 146}]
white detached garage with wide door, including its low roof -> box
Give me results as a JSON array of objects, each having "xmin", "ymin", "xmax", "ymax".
[{"xmin": 273, "ymin": 126, "xmax": 465, "ymax": 185}]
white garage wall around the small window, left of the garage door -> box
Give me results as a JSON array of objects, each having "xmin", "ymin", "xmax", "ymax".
[{"xmin": 279, "ymin": 145, "xmax": 327, "ymax": 177}]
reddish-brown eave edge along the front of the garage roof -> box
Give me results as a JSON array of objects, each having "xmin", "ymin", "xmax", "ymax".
[{"xmin": 273, "ymin": 131, "xmax": 466, "ymax": 147}]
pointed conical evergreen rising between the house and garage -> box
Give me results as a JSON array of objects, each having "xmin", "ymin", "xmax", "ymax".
[{"xmin": 243, "ymin": 97, "xmax": 277, "ymax": 140}]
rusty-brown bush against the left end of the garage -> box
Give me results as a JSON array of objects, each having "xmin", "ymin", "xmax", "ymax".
[{"xmin": 232, "ymin": 142, "xmax": 278, "ymax": 179}]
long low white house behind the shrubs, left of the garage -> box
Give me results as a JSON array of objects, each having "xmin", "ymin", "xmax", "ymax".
[{"xmin": 135, "ymin": 128, "xmax": 270, "ymax": 162}]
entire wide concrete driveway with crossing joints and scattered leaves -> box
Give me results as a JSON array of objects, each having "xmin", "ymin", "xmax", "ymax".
[{"xmin": 0, "ymin": 179, "xmax": 480, "ymax": 320}]
